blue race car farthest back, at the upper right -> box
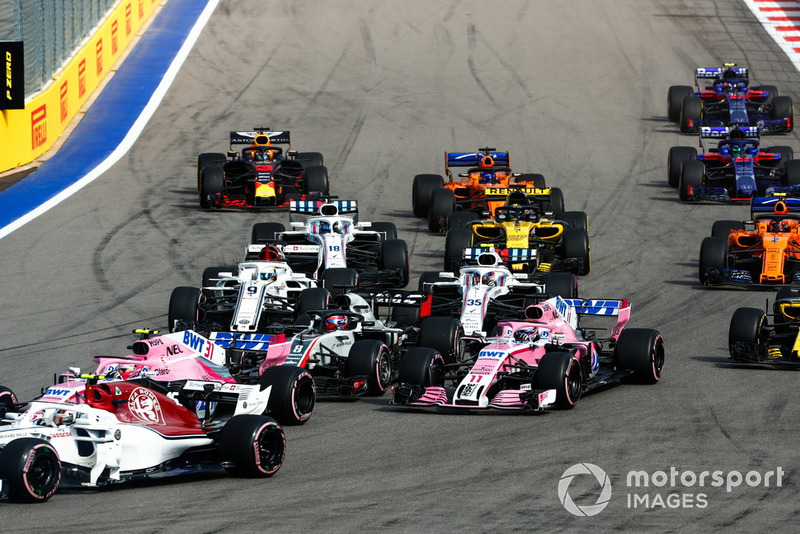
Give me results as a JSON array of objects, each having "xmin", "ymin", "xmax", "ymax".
[{"xmin": 667, "ymin": 63, "xmax": 794, "ymax": 133}]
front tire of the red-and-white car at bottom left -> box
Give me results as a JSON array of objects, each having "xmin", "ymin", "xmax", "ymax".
[{"xmin": 0, "ymin": 438, "xmax": 61, "ymax": 502}]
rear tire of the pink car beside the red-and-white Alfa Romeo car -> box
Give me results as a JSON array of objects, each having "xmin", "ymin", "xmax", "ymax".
[{"xmin": 258, "ymin": 365, "xmax": 317, "ymax": 425}]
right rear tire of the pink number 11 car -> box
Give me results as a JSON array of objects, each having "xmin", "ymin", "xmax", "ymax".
[{"xmin": 614, "ymin": 328, "xmax": 664, "ymax": 384}]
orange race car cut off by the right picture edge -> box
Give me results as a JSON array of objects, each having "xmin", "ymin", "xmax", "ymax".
[{"xmin": 699, "ymin": 196, "xmax": 800, "ymax": 288}]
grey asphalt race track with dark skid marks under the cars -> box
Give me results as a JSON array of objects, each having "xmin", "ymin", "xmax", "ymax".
[{"xmin": 0, "ymin": 0, "xmax": 800, "ymax": 533}]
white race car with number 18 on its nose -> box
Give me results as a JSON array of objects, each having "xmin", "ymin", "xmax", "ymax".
[{"xmin": 251, "ymin": 199, "xmax": 409, "ymax": 288}]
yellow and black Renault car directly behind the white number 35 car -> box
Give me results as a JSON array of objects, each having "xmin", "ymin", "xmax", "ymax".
[{"xmin": 444, "ymin": 201, "xmax": 592, "ymax": 275}]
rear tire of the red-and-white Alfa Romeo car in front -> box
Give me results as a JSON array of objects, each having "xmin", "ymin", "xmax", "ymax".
[{"xmin": 219, "ymin": 414, "xmax": 286, "ymax": 478}]
